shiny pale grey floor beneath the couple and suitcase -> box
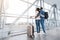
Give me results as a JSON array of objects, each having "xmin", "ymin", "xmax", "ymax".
[{"xmin": 0, "ymin": 28, "xmax": 60, "ymax": 40}]
